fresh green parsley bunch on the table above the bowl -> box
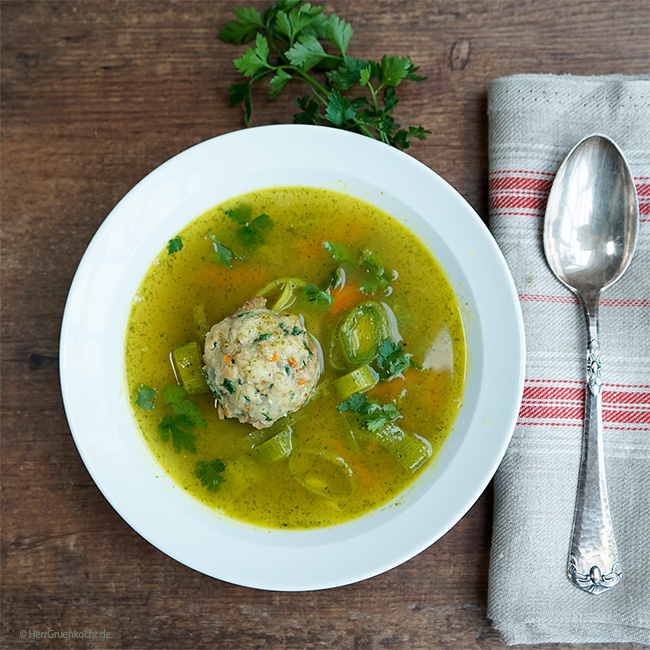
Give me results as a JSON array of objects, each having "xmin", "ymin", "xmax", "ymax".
[{"xmin": 219, "ymin": 0, "xmax": 431, "ymax": 149}]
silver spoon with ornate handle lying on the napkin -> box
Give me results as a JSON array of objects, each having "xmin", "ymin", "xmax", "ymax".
[{"xmin": 544, "ymin": 135, "xmax": 639, "ymax": 594}]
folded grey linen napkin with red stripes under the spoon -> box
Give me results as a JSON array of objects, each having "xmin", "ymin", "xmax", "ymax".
[{"xmin": 488, "ymin": 75, "xmax": 650, "ymax": 645}]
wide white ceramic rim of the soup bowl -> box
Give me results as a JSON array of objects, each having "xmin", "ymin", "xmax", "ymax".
[{"xmin": 60, "ymin": 125, "xmax": 525, "ymax": 591}]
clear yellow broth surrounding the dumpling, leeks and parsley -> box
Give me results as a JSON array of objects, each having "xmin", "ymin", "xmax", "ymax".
[{"xmin": 125, "ymin": 187, "xmax": 467, "ymax": 529}]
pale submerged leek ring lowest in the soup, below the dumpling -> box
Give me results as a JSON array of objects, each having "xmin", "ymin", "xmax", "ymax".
[{"xmin": 289, "ymin": 449, "xmax": 354, "ymax": 501}]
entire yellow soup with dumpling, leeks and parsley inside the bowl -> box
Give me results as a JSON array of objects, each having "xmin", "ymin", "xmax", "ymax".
[{"xmin": 126, "ymin": 187, "xmax": 466, "ymax": 529}]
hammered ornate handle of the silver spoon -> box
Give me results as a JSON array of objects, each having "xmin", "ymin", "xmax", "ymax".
[{"xmin": 567, "ymin": 294, "xmax": 621, "ymax": 594}]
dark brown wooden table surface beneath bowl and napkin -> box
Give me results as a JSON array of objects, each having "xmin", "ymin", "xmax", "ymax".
[{"xmin": 1, "ymin": 0, "xmax": 650, "ymax": 650}]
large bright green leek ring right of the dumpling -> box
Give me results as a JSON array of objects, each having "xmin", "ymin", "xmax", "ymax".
[{"xmin": 335, "ymin": 300, "xmax": 390, "ymax": 364}]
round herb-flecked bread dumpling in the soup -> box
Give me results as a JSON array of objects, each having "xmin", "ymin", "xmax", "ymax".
[{"xmin": 203, "ymin": 296, "xmax": 321, "ymax": 429}]
